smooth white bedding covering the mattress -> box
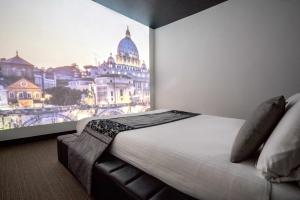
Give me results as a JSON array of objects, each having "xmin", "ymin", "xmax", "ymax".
[{"xmin": 77, "ymin": 110, "xmax": 300, "ymax": 200}]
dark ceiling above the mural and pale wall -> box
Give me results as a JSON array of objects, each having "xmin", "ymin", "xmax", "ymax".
[{"xmin": 94, "ymin": 0, "xmax": 226, "ymax": 29}]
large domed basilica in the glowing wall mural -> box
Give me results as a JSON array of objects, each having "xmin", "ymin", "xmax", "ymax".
[{"xmin": 95, "ymin": 28, "xmax": 150, "ymax": 105}]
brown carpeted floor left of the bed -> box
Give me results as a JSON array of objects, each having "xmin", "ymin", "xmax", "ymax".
[{"xmin": 0, "ymin": 139, "xmax": 89, "ymax": 200}]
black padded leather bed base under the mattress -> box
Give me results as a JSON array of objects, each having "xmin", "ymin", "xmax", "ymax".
[{"xmin": 57, "ymin": 134, "xmax": 195, "ymax": 200}]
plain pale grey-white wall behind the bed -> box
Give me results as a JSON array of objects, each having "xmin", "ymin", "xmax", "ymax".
[{"xmin": 155, "ymin": 0, "xmax": 300, "ymax": 118}]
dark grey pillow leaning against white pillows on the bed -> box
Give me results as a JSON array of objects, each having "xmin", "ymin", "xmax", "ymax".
[{"xmin": 230, "ymin": 96, "xmax": 285, "ymax": 163}]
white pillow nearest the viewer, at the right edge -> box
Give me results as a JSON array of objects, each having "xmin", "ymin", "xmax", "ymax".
[{"xmin": 256, "ymin": 101, "xmax": 300, "ymax": 182}]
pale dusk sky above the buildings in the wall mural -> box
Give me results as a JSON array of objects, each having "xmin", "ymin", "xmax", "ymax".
[{"xmin": 0, "ymin": 0, "xmax": 149, "ymax": 67}]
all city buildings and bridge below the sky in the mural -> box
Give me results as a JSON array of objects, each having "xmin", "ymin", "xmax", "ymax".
[{"xmin": 0, "ymin": 28, "xmax": 150, "ymax": 130}]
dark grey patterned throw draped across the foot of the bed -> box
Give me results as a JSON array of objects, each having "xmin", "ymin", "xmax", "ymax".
[{"xmin": 68, "ymin": 110, "xmax": 198, "ymax": 193}]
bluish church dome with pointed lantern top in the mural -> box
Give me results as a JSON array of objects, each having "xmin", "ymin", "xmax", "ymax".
[{"xmin": 118, "ymin": 27, "xmax": 139, "ymax": 59}]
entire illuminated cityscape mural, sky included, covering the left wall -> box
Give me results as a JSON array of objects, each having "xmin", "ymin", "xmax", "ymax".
[{"xmin": 0, "ymin": 0, "xmax": 150, "ymax": 130}]
